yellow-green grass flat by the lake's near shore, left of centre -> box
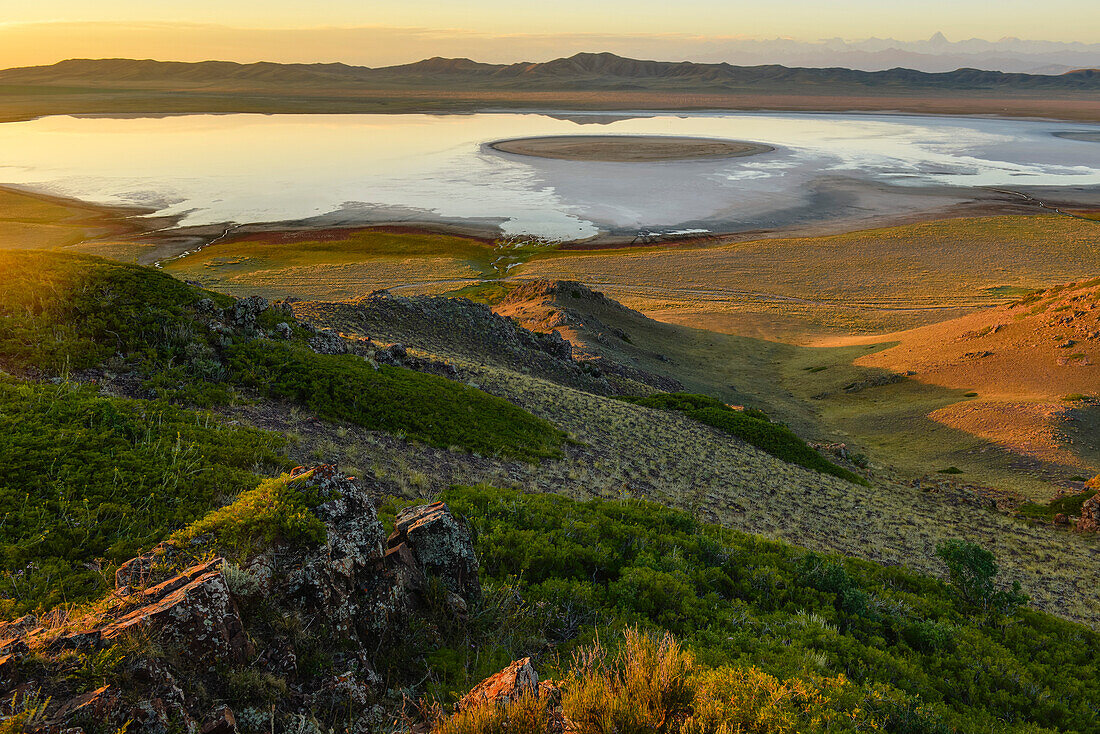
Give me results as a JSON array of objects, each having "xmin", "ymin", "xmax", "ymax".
[{"xmin": 165, "ymin": 230, "xmax": 493, "ymax": 300}]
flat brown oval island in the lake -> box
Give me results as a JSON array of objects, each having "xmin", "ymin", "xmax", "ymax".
[{"xmin": 487, "ymin": 135, "xmax": 776, "ymax": 163}]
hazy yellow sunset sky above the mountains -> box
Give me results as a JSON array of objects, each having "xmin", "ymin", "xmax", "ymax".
[{"xmin": 0, "ymin": 0, "xmax": 1100, "ymax": 67}]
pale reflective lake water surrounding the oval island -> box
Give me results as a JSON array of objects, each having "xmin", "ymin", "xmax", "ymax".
[{"xmin": 0, "ymin": 112, "xmax": 1100, "ymax": 239}]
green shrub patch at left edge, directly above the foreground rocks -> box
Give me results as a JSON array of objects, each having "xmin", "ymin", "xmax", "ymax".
[{"xmin": 0, "ymin": 379, "xmax": 286, "ymax": 616}]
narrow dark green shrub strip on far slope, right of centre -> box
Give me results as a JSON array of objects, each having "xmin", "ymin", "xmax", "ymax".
[{"xmin": 623, "ymin": 393, "xmax": 867, "ymax": 484}]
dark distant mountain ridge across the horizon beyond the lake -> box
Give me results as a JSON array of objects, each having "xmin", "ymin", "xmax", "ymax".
[{"xmin": 0, "ymin": 53, "xmax": 1100, "ymax": 91}]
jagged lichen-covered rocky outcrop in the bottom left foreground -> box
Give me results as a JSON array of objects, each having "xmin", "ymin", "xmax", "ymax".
[{"xmin": 0, "ymin": 465, "xmax": 481, "ymax": 734}]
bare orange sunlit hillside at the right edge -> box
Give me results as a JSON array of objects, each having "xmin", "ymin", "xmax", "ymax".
[{"xmin": 856, "ymin": 281, "xmax": 1100, "ymax": 474}]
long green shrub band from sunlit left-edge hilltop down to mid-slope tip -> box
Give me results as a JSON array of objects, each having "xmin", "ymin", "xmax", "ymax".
[{"xmin": 0, "ymin": 252, "xmax": 562, "ymax": 460}]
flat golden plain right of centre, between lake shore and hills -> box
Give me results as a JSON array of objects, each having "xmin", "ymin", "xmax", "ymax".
[{"xmin": 515, "ymin": 215, "xmax": 1100, "ymax": 342}]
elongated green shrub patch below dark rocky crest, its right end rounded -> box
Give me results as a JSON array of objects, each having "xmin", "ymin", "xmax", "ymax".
[{"xmin": 229, "ymin": 341, "xmax": 564, "ymax": 461}]
